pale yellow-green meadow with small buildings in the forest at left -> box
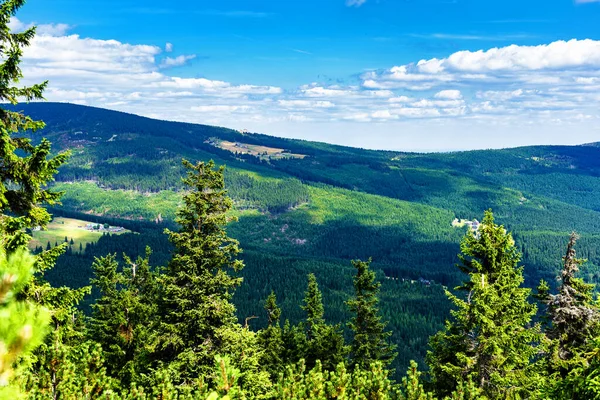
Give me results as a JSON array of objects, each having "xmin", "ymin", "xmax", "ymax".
[{"xmin": 29, "ymin": 218, "xmax": 131, "ymax": 253}]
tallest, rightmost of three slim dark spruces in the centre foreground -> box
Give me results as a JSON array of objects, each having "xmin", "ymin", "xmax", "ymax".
[{"xmin": 346, "ymin": 261, "xmax": 396, "ymax": 369}]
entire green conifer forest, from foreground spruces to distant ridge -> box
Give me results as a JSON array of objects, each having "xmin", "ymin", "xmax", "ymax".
[{"xmin": 0, "ymin": 0, "xmax": 600, "ymax": 400}]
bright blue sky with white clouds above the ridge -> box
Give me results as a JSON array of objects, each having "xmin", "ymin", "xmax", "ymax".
[{"xmin": 11, "ymin": 0, "xmax": 600, "ymax": 151}]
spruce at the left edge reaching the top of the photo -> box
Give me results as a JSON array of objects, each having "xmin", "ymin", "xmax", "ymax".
[{"xmin": 0, "ymin": 0, "xmax": 68, "ymax": 251}]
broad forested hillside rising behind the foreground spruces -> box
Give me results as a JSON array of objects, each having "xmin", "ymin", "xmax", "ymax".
[{"xmin": 17, "ymin": 103, "xmax": 600, "ymax": 371}]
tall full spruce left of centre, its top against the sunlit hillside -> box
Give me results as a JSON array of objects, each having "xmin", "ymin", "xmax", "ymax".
[{"xmin": 154, "ymin": 161, "xmax": 243, "ymax": 380}]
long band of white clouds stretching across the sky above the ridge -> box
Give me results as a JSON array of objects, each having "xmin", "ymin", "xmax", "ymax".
[{"xmin": 16, "ymin": 19, "xmax": 600, "ymax": 147}]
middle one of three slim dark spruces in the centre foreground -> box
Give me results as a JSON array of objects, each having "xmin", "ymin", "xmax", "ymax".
[{"xmin": 302, "ymin": 274, "xmax": 349, "ymax": 370}]
